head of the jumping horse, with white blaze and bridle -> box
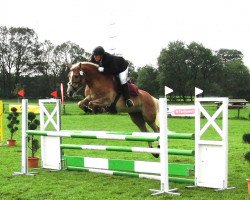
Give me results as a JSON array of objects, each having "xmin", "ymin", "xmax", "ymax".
[{"xmin": 67, "ymin": 63, "xmax": 85, "ymax": 97}]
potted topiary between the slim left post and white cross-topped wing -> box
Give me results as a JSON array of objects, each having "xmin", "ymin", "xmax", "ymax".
[{"xmin": 28, "ymin": 112, "xmax": 40, "ymax": 168}]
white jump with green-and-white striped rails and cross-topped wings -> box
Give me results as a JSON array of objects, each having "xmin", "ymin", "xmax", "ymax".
[{"xmin": 13, "ymin": 87, "xmax": 232, "ymax": 194}]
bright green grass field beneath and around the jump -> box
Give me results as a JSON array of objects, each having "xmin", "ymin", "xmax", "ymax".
[{"xmin": 0, "ymin": 103, "xmax": 250, "ymax": 200}]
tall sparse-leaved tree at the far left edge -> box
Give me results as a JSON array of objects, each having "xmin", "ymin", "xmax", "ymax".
[{"xmin": 0, "ymin": 27, "xmax": 37, "ymax": 97}]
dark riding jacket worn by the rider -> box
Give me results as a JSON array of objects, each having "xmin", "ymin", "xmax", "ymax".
[{"xmin": 90, "ymin": 52, "xmax": 129, "ymax": 75}]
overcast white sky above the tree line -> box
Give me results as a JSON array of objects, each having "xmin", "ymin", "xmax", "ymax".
[{"xmin": 0, "ymin": 0, "xmax": 250, "ymax": 67}]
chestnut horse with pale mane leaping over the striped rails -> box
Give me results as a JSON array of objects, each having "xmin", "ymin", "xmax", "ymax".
[{"xmin": 67, "ymin": 62, "xmax": 159, "ymax": 157}]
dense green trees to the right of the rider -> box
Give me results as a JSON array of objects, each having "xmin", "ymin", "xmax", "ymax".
[{"xmin": 135, "ymin": 41, "xmax": 250, "ymax": 101}]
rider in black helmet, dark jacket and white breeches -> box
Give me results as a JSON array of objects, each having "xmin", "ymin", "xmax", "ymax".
[{"xmin": 90, "ymin": 46, "xmax": 134, "ymax": 107}]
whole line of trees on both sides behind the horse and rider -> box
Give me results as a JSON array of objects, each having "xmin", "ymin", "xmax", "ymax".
[{"xmin": 0, "ymin": 26, "xmax": 250, "ymax": 101}]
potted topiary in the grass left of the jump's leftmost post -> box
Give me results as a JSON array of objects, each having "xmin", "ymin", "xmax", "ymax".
[{"xmin": 7, "ymin": 107, "xmax": 19, "ymax": 146}]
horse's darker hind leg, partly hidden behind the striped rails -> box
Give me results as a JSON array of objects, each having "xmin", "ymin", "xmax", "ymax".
[{"xmin": 129, "ymin": 112, "xmax": 159, "ymax": 158}]
